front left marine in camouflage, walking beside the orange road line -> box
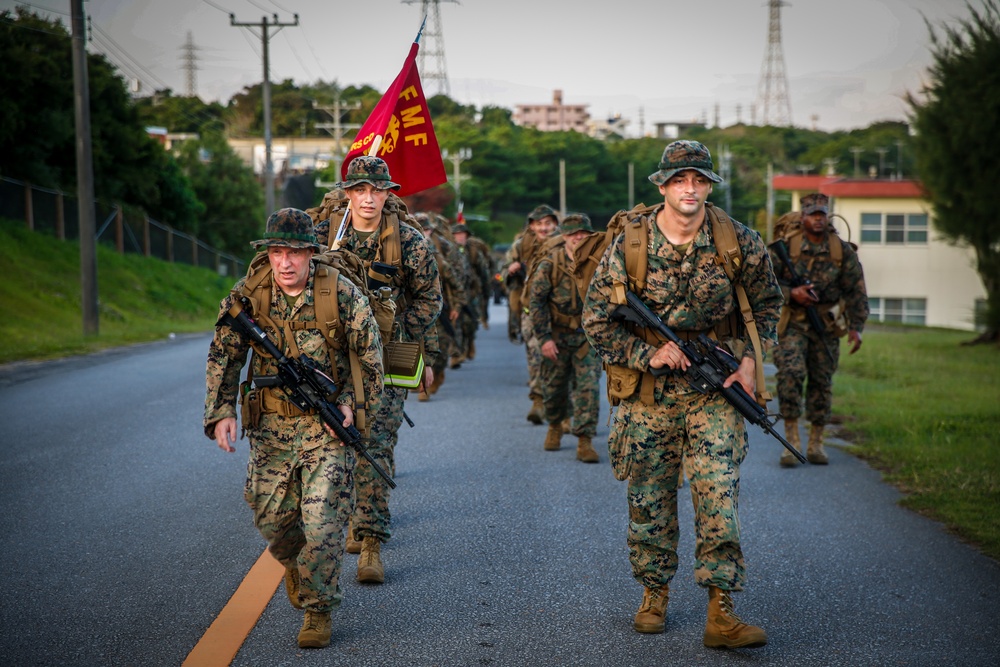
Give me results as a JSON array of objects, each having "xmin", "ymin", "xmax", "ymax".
[{"xmin": 204, "ymin": 209, "xmax": 383, "ymax": 647}]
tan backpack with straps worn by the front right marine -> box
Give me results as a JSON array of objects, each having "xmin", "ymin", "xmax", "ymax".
[{"xmin": 596, "ymin": 202, "xmax": 771, "ymax": 406}]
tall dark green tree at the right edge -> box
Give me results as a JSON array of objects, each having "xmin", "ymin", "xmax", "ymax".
[{"xmin": 907, "ymin": 0, "xmax": 1000, "ymax": 341}]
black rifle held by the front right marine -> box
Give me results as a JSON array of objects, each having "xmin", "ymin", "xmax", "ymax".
[{"xmin": 612, "ymin": 292, "xmax": 806, "ymax": 463}]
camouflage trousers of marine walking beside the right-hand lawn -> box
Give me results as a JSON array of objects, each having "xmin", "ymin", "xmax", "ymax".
[{"xmin": 774, "ymin": 326, "xmax": 840, "ymax": 426}]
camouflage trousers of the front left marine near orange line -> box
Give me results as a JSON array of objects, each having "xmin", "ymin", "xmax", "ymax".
[{"xmin": 244, "ymin": 416, "xmax": 354, "ymax": 611}]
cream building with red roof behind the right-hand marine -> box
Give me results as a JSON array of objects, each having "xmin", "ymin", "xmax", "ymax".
[{"xmin": 773, "ymin": 175, "xmax": 986, "ymax": 331}]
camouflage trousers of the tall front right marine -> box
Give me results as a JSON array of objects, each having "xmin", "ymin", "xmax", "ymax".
[{"xmin": 609, "ymin": 391, "xmax": 747, "ymax": 591}]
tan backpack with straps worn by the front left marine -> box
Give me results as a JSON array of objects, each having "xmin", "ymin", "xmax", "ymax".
[{"xmin": 239, "ymin": 250, "xmax": 396, "ymax": 438}]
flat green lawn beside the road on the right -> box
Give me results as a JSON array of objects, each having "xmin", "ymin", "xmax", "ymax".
[{"xmin": 834, "ymin": 327, "xmax": 1000, "ymax": 559}]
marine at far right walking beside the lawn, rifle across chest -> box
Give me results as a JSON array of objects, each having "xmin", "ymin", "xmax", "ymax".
[{"xmin": 771, "ymin": 193, "xmax": 868, "ymax": 468}]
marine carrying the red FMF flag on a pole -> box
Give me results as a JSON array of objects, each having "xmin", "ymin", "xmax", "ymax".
[{"xmin": 331, "ymin": 156, "xmax": 442, "ymax": 583}]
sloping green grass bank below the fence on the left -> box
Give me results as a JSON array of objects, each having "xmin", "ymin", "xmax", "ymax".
[{"xmin": 0, "ymin": 220, "xmax": 234, "ymax": 363}]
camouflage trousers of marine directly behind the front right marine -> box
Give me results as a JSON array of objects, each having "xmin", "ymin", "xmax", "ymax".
[{"xmin": 539, "ymin": 333, "xmax": 601, "ymax": 437}]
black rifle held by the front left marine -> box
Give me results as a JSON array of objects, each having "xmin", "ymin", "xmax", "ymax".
[{"xmin": 218, "ymin": 297, "xmax": 396, "ymax": 488}]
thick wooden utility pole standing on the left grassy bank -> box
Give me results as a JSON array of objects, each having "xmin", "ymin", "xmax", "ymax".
[{"xmin": 71, "ymin": 0, "xmax": 98, "ymax": 336}]
